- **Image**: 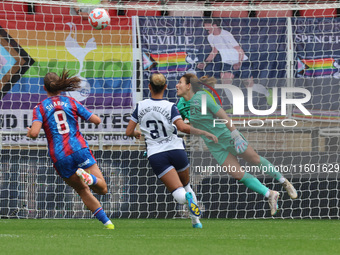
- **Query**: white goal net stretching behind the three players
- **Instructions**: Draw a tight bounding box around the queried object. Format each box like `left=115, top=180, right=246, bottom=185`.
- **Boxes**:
left=0, top=0, right=340, bottom=218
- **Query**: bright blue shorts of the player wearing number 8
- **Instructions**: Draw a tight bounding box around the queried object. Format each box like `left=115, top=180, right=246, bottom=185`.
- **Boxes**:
left=54, top=148, right=97, bottom=178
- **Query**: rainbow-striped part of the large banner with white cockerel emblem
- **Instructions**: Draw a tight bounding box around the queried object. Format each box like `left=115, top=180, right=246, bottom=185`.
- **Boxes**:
left=0, top=15, right=133, bottom=110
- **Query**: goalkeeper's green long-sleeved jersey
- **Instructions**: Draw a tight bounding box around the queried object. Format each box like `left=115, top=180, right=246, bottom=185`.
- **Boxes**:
left=177, top=91, right=230, bottom=145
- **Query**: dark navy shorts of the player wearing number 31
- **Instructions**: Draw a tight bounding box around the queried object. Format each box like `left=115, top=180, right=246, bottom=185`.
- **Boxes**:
left=149, top=150, right=190, bottom=178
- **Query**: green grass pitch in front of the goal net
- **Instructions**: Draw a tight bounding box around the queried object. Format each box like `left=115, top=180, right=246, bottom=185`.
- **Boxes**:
left=0, top=219, right=340, bottom=255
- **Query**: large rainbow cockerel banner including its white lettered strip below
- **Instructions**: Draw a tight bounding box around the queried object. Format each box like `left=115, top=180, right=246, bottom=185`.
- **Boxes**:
left=0, top=14, right=134, bottom=135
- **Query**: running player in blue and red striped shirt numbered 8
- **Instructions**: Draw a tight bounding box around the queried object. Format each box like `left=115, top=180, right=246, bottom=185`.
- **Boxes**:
left=27, top=70, right=114, bottom=229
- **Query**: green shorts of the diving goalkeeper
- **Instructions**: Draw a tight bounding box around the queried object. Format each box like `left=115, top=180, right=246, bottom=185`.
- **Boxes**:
left=204, top=132, right=246, bottom=165
